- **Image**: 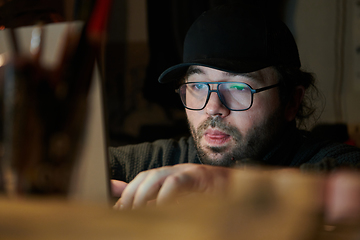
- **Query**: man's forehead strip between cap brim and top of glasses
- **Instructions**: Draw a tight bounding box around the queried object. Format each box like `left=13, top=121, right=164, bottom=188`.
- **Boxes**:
left=185, top=65, right=277, bottom=83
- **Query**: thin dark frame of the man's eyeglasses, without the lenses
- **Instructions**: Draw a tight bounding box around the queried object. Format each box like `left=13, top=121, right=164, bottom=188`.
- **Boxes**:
left=175, top=82, right=280, bottom=111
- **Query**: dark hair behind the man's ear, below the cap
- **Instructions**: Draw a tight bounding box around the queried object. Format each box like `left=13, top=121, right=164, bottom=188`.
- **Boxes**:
left=274, top=66, right=319, bottom=127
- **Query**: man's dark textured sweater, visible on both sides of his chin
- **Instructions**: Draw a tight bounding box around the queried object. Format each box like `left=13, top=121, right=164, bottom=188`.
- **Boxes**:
left=109, top=129, right=360, bottom=182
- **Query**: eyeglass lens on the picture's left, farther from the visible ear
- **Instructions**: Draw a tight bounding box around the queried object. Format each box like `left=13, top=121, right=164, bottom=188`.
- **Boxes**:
left=179, top=83, right=209, bottom=110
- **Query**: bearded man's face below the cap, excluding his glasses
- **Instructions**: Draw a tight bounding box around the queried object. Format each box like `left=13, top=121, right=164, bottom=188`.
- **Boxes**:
left=186, top=66, right=286, bottom=166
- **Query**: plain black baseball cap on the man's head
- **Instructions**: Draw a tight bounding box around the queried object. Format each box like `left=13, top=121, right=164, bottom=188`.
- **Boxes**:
left=159, top=4, right=301, bottom=83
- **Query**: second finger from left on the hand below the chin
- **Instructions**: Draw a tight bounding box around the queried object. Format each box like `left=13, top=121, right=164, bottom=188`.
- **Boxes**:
left=133, top=167, right=176, bottom=209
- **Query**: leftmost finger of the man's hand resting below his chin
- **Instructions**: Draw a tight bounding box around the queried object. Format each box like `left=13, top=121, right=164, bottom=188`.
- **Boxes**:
left=119, top=171, right=150, bottom=209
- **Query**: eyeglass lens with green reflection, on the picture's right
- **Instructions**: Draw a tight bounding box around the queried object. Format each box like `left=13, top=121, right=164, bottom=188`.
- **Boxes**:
left=218, top=82, right=252, bottom=110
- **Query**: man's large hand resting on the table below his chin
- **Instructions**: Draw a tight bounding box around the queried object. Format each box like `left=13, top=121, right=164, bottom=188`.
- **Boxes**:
left=114, top=163, right=234, bottom=209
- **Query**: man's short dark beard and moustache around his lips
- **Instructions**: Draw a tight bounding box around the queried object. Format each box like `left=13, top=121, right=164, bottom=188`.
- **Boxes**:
left=189, top=108, right=286, bottom=167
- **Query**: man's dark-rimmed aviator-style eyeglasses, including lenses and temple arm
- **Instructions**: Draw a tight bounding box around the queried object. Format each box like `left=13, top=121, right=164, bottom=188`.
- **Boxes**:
left=175, top=82, right=279, bottom=111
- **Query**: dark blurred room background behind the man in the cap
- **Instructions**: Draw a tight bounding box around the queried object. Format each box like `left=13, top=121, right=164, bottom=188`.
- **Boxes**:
left=0, top=0, right=360, bottom=146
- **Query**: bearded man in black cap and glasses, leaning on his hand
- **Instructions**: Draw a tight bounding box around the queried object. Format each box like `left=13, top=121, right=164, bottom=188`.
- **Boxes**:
left=110, top=4, right=360, bottom=209
